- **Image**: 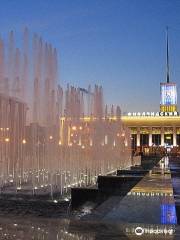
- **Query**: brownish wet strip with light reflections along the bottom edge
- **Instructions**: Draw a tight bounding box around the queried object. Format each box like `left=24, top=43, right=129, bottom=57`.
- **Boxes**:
left=0, top=217, right=177, bottom=240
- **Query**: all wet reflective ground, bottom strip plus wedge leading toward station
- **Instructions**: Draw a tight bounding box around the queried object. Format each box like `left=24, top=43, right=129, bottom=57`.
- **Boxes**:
left=0, top=158, right=180, bottom=240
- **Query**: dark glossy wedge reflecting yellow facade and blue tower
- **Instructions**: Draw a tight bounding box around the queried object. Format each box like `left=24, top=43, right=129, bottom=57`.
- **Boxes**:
left=83, top=158, right=177, bottom=224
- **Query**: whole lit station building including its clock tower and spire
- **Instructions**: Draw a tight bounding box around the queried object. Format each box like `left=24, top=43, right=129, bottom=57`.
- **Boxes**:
left=122, top=28, right=180, bottom=155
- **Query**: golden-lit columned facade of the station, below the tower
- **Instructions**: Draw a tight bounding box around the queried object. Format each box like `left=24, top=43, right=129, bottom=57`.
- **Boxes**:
left=122, top=112, right=180, bottom=155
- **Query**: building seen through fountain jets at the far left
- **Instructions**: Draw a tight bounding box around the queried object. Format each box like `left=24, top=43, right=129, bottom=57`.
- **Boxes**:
left=0, top=93, right=27, bottom=177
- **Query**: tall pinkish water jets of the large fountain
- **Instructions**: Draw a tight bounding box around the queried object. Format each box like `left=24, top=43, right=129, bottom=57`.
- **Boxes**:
left=0, top=28, right=131, bottom=201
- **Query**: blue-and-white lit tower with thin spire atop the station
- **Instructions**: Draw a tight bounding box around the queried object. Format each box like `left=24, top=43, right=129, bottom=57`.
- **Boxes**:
left=160, top=27, right=177, bottom=112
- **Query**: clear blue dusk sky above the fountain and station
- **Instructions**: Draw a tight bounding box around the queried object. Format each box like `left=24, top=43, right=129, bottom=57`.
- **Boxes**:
left=0, top=0, right=180, bottom=111
